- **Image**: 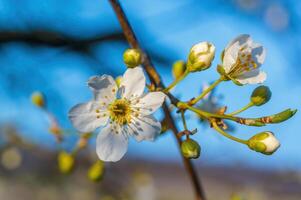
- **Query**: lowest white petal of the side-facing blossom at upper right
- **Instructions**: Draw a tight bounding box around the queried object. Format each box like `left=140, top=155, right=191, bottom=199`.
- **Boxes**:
left=236, top=70, right=267, bottom=84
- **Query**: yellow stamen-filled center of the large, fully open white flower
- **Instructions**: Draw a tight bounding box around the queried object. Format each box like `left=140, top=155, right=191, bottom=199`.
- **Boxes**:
left=109, top=99, right=132, bottom=125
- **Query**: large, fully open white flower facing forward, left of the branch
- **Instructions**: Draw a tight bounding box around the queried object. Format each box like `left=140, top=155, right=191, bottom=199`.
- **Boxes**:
left=69, top=67, right=165, bottom=162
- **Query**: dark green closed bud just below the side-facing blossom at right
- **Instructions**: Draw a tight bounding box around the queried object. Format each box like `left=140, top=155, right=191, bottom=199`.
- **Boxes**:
left=251, top=85, right=272, bottom=106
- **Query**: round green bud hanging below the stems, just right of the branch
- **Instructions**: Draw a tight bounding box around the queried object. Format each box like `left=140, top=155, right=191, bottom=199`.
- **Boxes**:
left=181, top=139, right=201, bottom=159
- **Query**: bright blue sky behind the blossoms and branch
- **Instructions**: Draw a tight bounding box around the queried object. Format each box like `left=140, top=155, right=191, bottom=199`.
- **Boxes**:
left=0, top=0, right=301, bottom=169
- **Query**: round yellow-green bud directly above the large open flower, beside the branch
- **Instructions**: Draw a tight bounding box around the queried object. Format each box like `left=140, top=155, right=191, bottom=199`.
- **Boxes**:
left=123, top=49, right=142, bottom=68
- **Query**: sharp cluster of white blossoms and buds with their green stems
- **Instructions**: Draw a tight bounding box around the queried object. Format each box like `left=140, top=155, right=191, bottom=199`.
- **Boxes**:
left=69, top=35, right=296, bottom=162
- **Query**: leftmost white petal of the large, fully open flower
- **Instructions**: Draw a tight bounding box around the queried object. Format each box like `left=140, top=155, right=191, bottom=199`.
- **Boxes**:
left=68, top=101, right=108, bottom=132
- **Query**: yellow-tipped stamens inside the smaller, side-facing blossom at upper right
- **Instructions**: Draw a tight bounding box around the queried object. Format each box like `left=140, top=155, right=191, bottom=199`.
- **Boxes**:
left=229, top=47, right=257, bottom=77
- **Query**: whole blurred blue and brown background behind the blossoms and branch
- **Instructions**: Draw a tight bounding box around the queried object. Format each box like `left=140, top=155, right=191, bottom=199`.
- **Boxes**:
left=0, top=0, right=301, bottom=200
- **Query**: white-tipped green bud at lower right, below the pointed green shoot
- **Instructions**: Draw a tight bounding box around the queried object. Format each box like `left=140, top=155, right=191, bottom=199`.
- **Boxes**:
left=248, top=131, right=280, bottom=155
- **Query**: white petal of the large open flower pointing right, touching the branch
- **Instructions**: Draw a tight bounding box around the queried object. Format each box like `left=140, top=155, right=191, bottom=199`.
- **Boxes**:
left=132, top=92, right=166, bottom=115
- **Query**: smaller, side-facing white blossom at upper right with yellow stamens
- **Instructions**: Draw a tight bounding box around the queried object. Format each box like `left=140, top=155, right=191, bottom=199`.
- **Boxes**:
left=222, top=34, right=266, bottom=84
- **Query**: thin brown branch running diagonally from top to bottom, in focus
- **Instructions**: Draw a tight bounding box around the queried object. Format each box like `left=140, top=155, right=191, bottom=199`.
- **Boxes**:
left=109, top=0, right=205, bottom=200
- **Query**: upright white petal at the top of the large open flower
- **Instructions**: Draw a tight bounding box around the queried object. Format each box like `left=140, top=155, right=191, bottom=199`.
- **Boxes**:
left=120, top=67, right=145, bottom=99
